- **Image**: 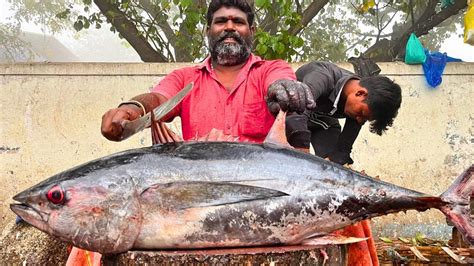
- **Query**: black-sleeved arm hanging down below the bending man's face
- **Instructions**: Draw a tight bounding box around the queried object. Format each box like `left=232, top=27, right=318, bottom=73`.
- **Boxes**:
left=328, top=118, right=362, bottom=165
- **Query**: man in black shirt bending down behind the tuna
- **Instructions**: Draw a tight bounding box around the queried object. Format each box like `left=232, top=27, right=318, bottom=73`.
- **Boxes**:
left=286, top=62, right=402, bottom=165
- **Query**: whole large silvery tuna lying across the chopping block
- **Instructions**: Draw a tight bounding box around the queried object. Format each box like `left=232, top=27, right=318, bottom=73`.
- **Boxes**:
left=11, top=115, right=474, bottom=253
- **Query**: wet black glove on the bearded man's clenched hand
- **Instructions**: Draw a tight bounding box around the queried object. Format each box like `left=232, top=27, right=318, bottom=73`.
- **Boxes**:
left=266, top=79, right=316, bottom=115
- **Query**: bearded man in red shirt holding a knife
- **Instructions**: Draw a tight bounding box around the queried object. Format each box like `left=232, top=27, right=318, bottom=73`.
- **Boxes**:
left=101, top=0, right=315, bottom=142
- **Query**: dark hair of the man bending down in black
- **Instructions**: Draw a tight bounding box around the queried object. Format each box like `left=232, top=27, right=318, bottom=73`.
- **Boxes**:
left=359, top=76, right=402, bottom=135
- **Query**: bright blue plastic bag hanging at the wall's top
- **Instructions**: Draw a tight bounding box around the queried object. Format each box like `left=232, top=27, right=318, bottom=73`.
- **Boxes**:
left=423, top=50, right=461, bottom=88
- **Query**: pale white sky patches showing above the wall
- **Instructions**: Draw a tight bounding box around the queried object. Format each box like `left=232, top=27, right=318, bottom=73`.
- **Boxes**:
left=0, top=0, right=474, bottom=62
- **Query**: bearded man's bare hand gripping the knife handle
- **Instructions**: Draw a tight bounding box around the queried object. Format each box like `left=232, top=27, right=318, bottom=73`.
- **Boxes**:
left=100, top=104, right=143, bottom=141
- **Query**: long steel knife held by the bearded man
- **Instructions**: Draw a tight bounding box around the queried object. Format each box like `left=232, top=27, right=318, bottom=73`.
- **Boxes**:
left=121, top=82, right=194, bottom=140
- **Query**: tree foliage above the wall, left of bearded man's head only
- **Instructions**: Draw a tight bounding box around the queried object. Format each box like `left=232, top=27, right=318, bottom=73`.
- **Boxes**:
left=56, top=0, right=207, bottom=61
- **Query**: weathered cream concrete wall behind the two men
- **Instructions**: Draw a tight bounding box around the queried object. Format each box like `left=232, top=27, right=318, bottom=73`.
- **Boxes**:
left=0, top=63, right=474, bottom=237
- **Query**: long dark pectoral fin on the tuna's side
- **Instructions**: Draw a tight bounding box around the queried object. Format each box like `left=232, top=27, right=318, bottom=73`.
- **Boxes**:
left=141, top=181, right=288, bottom=209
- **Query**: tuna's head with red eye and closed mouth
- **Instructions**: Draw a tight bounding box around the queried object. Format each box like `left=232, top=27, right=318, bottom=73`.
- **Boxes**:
left=10, top=170, right=142, bottom=254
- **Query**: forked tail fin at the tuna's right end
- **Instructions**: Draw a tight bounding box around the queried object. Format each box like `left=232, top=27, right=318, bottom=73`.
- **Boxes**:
left=440, top=165, right=474, bottom=245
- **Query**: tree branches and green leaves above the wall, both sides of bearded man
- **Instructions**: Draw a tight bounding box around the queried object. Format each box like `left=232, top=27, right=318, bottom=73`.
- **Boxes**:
left=1, top=0, right=466, bottom=62
